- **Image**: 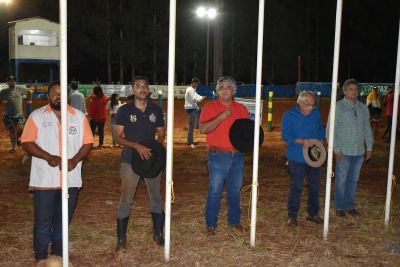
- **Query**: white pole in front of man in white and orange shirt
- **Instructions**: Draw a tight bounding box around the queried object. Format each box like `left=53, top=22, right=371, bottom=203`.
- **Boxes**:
left=60, top=0, right=69, bottom=266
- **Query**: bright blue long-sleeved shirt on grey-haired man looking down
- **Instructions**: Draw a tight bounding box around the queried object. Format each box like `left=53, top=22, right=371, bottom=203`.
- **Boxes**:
left=282, top=106, right=325, bottom=163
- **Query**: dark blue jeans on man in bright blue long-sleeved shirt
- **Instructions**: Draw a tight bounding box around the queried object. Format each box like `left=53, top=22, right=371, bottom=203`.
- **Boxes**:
left=288, top=160, right=322, bottom=219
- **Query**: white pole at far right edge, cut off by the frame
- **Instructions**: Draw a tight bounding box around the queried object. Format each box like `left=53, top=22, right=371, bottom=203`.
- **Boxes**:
left=385, top=19, right=400, bottom=229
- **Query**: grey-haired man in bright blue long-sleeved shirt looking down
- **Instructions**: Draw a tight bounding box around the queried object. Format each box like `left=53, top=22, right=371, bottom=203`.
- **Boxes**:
left=282, top=91, right=325, bottom=227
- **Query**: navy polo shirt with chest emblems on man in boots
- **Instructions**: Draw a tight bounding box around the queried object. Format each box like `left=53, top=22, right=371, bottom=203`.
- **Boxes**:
left=115, top=101, right=164, bottom=163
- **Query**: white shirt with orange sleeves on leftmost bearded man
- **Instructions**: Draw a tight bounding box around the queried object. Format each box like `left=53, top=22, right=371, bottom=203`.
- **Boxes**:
left=21, top=105, right=93, bottom=189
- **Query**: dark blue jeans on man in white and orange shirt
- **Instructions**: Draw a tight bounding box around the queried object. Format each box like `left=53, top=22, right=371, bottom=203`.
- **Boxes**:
left=33, top=187, right=78, bottom=261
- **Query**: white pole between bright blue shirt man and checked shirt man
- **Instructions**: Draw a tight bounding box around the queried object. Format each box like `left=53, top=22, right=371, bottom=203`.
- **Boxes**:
left=323, top=0, right=343, bottom=243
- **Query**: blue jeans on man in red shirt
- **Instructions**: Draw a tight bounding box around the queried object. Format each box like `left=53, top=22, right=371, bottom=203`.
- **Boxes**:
left=205, top=151, right=244, bottom=227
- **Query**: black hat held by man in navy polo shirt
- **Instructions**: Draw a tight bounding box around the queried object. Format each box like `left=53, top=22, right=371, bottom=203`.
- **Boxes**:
left=131, top=140, right=166, bottom=178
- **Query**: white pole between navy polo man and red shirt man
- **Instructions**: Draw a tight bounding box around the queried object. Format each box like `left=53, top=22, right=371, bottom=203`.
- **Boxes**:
left=164, top=0, right=176, bottom=261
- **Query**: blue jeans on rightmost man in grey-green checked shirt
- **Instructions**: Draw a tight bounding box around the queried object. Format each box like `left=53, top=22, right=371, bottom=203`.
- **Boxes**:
left=335, top=155, right=364, bottom=210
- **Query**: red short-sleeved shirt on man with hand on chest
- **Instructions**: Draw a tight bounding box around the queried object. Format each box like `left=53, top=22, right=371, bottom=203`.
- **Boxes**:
left=200, top=99, right=249, bottom=149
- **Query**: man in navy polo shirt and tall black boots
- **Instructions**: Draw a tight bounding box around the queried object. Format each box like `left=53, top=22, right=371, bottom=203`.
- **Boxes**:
left=114, top=76, right=165, bottom=251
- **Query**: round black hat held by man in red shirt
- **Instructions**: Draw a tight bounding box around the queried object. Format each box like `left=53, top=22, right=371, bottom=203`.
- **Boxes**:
left=229, top=119, right=264, bottom=152
